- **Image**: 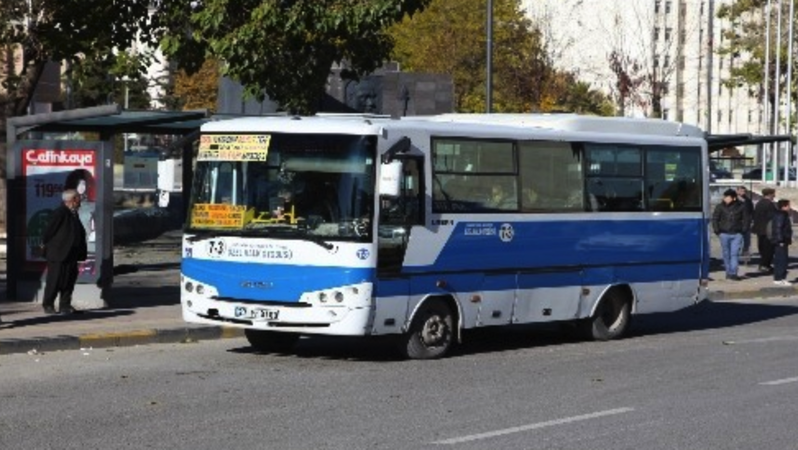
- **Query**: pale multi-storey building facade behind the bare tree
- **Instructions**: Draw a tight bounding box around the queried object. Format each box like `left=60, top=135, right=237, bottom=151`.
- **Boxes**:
left=522, top=0, right=765, bottom=134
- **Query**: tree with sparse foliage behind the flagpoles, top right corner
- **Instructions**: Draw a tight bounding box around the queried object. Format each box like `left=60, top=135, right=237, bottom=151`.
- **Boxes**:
left=717, top=0, right=798, bottom=124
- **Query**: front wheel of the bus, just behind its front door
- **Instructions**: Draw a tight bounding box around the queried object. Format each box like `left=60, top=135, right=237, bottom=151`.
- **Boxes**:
left=399, top=300, right=454, bottom=359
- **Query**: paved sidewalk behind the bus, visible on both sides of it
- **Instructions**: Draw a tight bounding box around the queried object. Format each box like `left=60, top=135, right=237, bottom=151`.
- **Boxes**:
left=0, top=181, right=798, bottom=354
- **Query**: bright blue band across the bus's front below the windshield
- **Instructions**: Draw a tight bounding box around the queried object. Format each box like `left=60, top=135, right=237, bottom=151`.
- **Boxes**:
left=181, top=258, right=374, bottom=303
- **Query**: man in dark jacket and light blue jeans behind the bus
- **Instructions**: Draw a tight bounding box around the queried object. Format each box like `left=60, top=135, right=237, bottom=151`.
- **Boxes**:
left=712, top=189, right=751, bottom=280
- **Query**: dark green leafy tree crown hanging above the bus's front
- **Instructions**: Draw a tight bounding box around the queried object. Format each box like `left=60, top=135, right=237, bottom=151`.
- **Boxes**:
left=152, top=0, right=429, bottom=113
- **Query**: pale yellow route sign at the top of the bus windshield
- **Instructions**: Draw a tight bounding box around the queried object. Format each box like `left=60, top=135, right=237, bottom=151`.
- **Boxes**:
left=197, top=134, right=271, bottom=161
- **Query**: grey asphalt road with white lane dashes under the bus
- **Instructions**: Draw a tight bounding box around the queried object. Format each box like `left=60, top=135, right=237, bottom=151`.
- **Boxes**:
left=0, top=298, right=798, bottom=450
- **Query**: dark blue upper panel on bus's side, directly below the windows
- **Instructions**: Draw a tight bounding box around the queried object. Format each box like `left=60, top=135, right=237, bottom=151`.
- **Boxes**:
left=404, top=218, right=708, bottom=276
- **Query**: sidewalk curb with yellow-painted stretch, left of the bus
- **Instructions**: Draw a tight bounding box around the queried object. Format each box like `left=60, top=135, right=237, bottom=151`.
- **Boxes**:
left=0, top=326, right=244, bottom=355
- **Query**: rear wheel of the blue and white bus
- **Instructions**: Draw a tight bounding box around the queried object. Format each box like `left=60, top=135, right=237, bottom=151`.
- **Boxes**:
left=579, top=289, right=632, bottom=341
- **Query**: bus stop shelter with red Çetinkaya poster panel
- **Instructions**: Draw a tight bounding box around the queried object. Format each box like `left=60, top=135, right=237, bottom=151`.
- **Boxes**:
left=6, top=105, right=209, bottom=309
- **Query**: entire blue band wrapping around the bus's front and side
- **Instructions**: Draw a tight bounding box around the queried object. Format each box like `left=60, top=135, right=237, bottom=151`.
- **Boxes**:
left=183, top=218, right=709, bottom=302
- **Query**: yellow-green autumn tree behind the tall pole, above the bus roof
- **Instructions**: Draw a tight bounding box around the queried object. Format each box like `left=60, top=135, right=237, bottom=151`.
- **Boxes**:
left=391, top=0, right=612, bottom=114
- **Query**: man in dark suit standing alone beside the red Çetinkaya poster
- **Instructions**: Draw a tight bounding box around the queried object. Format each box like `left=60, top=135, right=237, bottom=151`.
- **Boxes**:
left=42, top=189, right=87, bottom=314
